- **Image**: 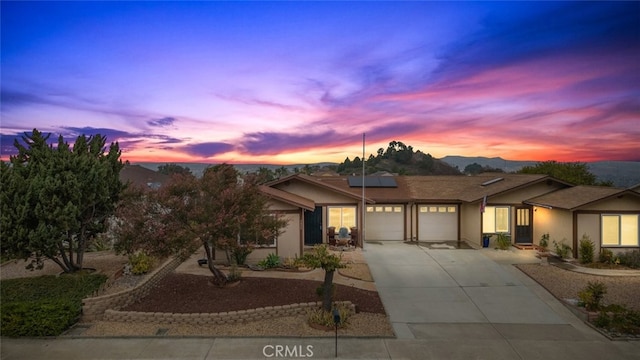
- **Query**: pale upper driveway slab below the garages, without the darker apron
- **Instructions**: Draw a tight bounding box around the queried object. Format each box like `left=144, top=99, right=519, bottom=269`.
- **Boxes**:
left=365, top=242, right=567, bottom=338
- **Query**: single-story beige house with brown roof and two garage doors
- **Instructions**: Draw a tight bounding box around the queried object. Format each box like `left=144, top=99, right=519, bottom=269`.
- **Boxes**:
left=256, top=173, right=640, bottom=261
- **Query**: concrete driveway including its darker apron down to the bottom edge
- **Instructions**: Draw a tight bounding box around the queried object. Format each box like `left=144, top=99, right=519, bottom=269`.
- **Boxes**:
left=364, top=241, right=640, bottom=359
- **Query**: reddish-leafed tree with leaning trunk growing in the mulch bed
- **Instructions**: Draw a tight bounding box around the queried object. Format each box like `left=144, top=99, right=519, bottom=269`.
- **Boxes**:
left=114, top=164, right=287, bottom=286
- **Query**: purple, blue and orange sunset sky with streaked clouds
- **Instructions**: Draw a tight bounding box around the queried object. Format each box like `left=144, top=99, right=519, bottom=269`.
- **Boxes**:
left=0, top=1, right=640, bottom=164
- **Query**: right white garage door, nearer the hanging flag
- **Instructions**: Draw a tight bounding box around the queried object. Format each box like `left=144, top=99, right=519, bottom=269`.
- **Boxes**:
left=418, top=205, right=458, bottom=241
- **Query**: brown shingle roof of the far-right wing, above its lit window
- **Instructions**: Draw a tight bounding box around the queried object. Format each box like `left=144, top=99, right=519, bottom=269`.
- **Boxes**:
left=525, top=185, right=639, bottom=210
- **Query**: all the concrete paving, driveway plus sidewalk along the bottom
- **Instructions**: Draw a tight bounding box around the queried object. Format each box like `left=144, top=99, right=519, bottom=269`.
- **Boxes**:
left=0, top=242, right=640, bottom=360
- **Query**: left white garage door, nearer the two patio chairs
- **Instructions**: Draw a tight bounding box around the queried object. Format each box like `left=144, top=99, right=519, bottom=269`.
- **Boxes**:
left=365, top=205, right=404, bottom=241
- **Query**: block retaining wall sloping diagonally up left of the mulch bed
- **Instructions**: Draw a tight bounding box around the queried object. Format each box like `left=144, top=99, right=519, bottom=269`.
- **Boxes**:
left=81, top=257, right=184, bottom=322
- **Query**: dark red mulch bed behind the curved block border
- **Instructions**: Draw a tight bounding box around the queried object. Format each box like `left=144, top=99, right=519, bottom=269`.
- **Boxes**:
left=122, top=273, right=385, bottom=314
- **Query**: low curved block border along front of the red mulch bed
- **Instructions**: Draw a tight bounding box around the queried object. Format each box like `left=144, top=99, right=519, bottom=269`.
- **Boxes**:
left=102, top=301, right=356, bottom=325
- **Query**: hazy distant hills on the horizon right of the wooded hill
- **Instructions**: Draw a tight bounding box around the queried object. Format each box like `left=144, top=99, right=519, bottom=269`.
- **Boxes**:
left=441, top=156, right=640, bottom=188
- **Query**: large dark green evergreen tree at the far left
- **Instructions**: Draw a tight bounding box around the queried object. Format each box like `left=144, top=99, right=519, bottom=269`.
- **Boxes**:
left=0, top=129, right=124, bottom=272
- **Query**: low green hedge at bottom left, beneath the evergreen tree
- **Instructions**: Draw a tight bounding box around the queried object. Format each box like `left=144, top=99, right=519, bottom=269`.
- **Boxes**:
left=0, top=274, right=107, bottom=336
